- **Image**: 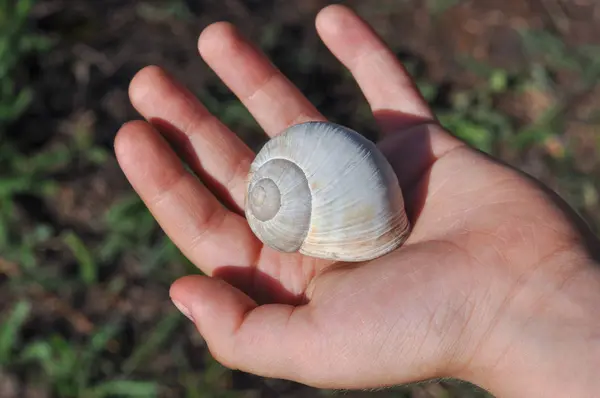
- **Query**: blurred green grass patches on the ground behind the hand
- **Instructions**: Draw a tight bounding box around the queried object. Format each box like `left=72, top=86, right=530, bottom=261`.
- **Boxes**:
left=0, top=0, right=600, bottom=398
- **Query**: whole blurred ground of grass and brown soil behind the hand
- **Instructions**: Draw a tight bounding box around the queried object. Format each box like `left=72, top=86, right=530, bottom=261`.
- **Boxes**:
left=0, top=0, right=600, bottom=398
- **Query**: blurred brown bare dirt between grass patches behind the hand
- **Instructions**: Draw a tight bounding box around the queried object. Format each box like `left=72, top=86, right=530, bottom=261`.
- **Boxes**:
left=7, top=0, right=600, bottom=397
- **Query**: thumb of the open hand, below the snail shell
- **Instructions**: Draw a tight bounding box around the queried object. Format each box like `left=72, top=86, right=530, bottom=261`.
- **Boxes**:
left=170, top=275, right=319, bottom=385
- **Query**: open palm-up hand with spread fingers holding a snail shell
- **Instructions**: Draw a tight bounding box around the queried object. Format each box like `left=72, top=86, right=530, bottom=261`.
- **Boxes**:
left=115, top=5, right=600, bottom=397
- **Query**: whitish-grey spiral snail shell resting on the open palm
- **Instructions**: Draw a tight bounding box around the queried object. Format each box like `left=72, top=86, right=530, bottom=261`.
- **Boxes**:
left=245, top=122, right=410, bottom=261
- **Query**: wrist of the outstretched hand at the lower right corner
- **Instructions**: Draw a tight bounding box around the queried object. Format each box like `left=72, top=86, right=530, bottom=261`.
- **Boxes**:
left=459, top=252, right=600, bottom=398
